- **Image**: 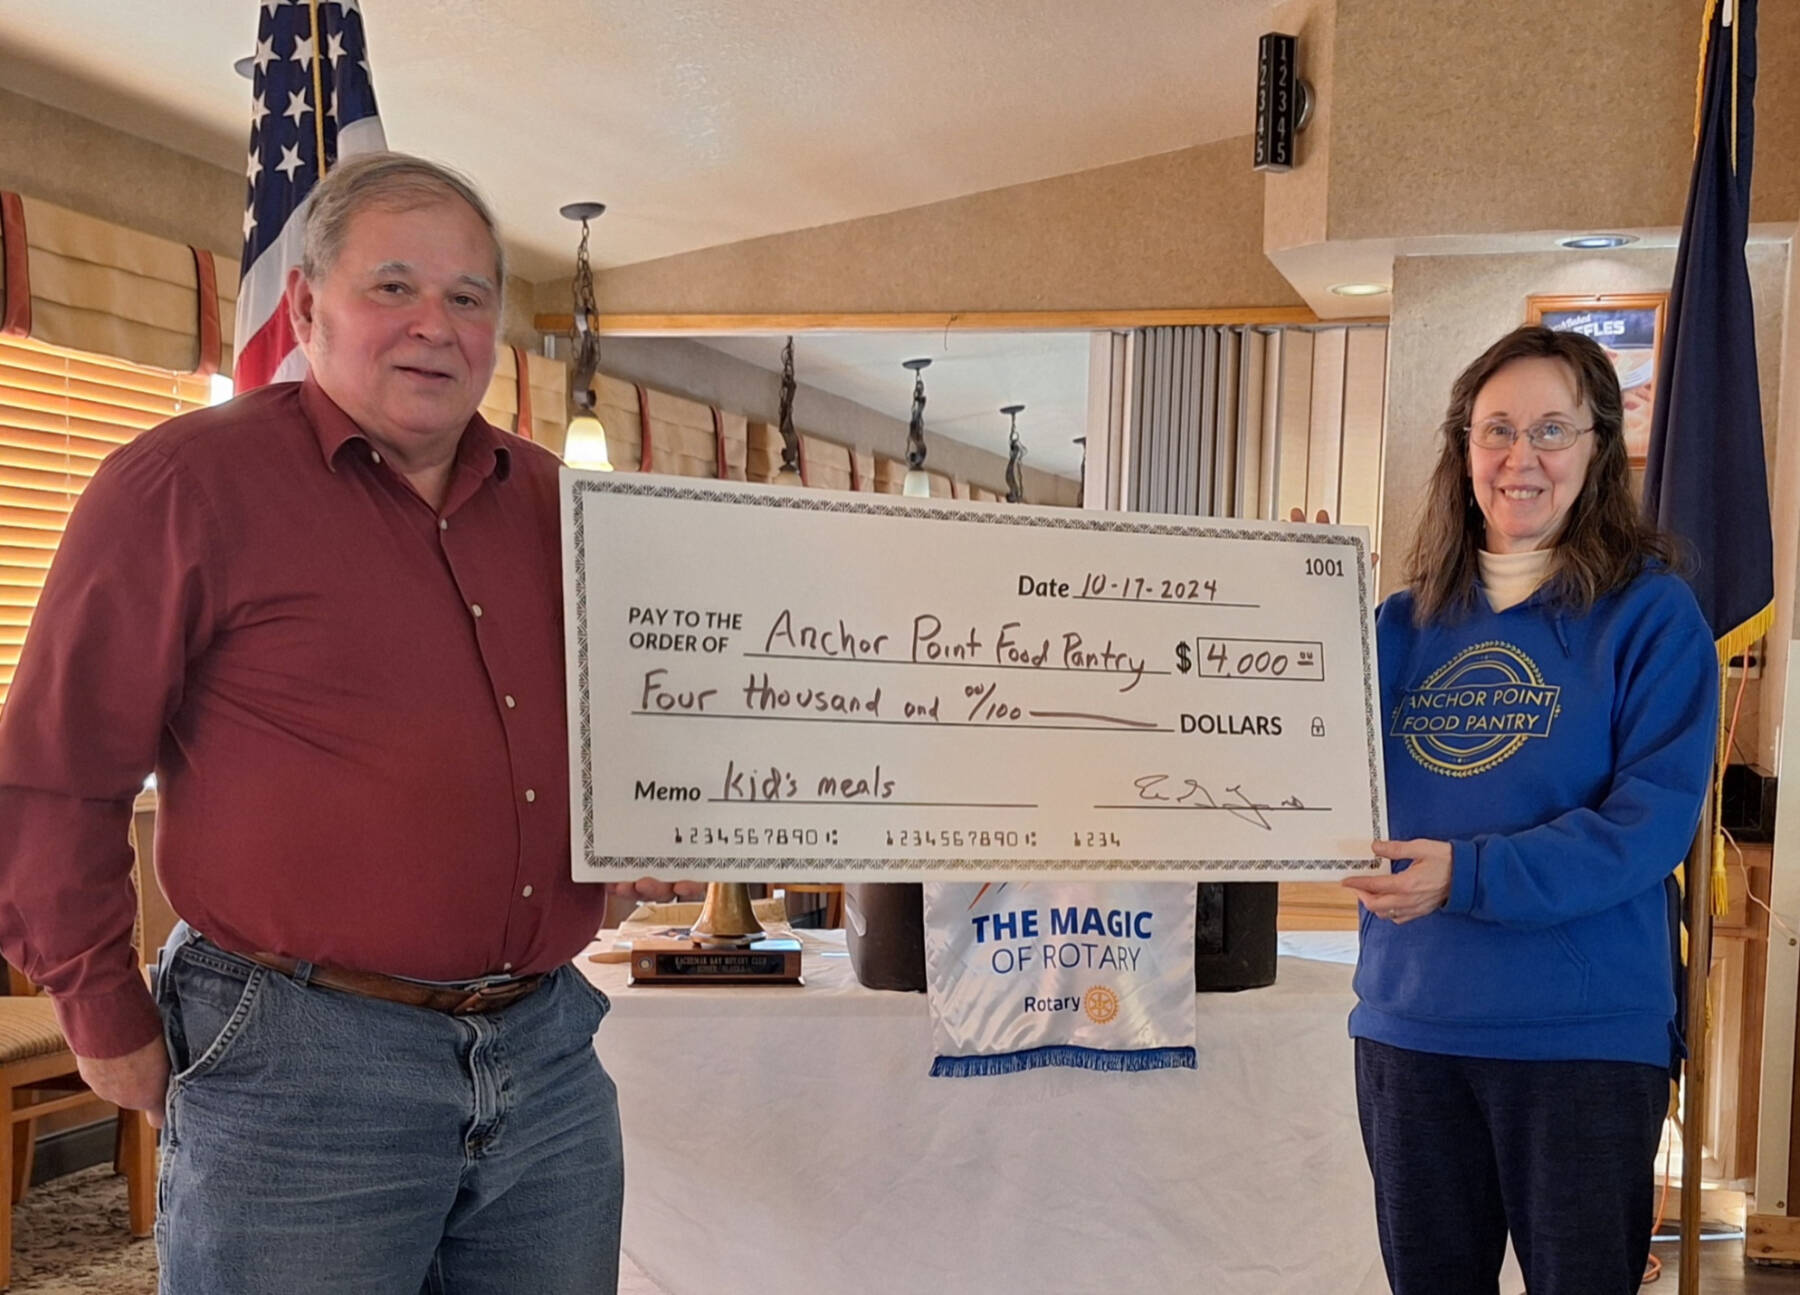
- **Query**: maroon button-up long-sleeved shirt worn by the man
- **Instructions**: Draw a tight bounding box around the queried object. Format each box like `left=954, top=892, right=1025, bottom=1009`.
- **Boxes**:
left=0, top=380, right=605, bottom=1057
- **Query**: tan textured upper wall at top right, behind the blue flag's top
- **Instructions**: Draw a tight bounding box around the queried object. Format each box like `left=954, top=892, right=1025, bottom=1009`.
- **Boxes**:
left=1328, top=0, right=1800, bottom=240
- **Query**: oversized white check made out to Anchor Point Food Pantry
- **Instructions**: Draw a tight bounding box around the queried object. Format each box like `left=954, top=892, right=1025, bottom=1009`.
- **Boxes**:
left=563, top=472, right=1384, bottom=881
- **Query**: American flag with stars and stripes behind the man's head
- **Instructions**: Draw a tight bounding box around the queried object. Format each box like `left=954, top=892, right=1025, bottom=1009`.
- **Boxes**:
left=232, top=0, right=387, bottom=391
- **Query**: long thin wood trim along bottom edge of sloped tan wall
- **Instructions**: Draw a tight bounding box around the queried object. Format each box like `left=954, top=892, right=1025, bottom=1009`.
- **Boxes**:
left=531, top=306, right=1324, bottom=337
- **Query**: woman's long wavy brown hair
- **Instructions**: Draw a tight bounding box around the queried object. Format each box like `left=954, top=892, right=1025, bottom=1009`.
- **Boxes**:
left=1408, top=324, right=1679, bottom=625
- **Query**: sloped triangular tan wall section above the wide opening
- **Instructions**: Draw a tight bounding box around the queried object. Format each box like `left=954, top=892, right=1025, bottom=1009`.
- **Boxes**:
left=572, top=137, right=1301, bottom=313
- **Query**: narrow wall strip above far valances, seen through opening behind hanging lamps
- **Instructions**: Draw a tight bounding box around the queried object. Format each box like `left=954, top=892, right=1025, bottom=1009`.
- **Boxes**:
left=599, top=337, right=1080, bottom=506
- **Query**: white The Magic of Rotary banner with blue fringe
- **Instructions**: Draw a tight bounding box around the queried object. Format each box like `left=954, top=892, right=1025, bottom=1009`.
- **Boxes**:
left=925, top=883, right=1195, bottom=1075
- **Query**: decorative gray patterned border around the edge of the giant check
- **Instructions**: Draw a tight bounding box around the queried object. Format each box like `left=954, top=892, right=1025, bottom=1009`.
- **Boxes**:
left=565, top=474, right=1388, bottom=879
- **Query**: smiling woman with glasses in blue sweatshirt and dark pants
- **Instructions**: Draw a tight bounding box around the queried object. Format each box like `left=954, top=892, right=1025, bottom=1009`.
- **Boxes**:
left=1345, top=328, right=1717, bottom=1295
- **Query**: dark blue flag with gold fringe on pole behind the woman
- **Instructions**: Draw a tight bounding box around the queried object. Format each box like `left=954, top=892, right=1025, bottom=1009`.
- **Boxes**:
left=1643, top=0, right=1775, bottom=665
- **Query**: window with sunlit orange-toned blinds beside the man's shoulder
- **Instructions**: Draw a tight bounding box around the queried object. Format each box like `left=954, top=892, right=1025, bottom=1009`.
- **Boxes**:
left=0, top=337, right=230, bottom=706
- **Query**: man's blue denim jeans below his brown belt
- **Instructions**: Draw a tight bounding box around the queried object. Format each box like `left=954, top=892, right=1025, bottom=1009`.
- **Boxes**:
left=157, top=926, right=623, bottom=1295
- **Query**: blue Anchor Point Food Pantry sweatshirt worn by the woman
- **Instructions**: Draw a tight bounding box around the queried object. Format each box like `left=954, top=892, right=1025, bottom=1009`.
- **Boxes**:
left=1350, top=569, right=1719, bottom=1066
